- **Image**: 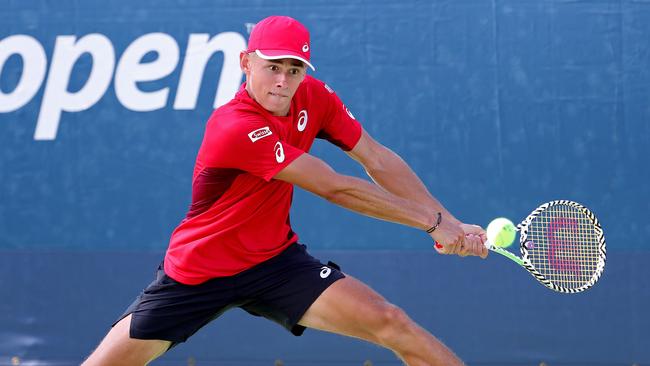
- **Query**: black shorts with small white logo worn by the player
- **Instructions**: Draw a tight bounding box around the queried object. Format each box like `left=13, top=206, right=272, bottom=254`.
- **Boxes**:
left=113, top=244, right=345, bottom=346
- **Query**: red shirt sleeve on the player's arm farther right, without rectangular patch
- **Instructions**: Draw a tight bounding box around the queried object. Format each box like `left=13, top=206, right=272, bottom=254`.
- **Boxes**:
left=316, top=84, right=362, bottom=151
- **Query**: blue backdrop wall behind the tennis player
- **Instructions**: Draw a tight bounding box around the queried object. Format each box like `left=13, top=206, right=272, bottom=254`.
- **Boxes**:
left=0, top=0, right=650, bottom=364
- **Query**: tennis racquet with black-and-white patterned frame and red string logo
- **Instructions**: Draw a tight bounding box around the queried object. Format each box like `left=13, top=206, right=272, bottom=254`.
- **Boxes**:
left=436, top=200, right=606, bottom=293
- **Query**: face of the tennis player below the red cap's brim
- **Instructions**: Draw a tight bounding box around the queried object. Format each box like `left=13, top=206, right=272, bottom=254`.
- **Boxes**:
left=239, top=52, right=307, bottom=116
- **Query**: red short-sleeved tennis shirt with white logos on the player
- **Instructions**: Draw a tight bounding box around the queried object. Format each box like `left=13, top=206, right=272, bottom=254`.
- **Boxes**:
left=165, top=76, right=361, bottom=285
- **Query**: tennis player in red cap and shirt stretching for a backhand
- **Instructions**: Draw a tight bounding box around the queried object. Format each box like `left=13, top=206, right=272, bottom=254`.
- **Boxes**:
left=84, top=16, right=487, bottom=365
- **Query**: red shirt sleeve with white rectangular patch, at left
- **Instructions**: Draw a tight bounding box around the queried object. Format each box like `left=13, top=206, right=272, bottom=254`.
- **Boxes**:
left=201, top=118, right=304, bottom=181
